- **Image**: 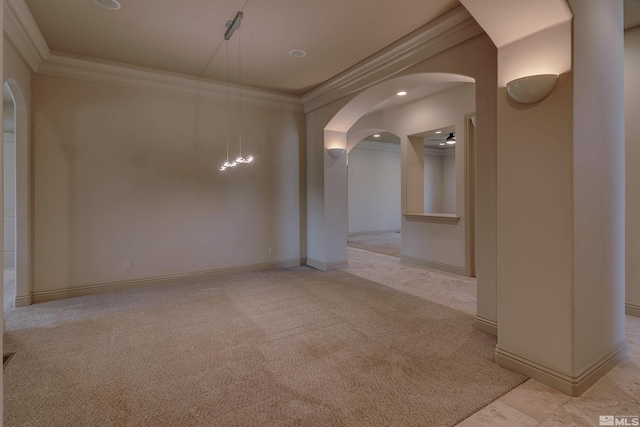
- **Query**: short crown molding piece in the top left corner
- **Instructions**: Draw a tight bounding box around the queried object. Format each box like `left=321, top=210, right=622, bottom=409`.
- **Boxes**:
left=3, top=0, right=49, bottom=72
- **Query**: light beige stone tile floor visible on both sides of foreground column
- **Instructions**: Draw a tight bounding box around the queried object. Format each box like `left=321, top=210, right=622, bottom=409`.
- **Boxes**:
left=346, top=242, right=640, bottom=427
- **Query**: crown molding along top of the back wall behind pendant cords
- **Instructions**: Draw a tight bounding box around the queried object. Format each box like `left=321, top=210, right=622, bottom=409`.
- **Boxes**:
left=38, top=52, right=303, bottom=113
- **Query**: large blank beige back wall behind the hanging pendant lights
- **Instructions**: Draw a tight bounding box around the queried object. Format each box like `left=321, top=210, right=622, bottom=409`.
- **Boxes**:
left=33, top=75, right=305, bottom=300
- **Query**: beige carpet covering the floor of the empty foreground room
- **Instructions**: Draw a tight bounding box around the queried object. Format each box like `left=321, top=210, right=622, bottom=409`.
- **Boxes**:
left=4, top=267, right=525, bottom=427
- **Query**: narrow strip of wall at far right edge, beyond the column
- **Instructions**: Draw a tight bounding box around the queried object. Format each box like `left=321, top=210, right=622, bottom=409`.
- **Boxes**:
left=624, top=27, right=640, bottom=316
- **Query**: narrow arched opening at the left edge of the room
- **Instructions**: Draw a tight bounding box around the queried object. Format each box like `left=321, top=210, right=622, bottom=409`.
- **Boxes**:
left=3, top=78, right=31, bottom=308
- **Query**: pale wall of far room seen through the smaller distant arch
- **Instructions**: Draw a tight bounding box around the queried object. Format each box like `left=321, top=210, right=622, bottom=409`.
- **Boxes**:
left=347, top=141, right=400, bottom=233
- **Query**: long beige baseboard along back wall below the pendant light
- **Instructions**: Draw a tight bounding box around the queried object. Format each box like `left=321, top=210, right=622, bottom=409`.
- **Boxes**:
left=33, top=258, right=304, bottom=303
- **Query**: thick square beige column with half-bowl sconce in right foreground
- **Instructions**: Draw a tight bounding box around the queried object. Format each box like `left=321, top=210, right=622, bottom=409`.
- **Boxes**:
left=496, top=0, right=626, bottom=395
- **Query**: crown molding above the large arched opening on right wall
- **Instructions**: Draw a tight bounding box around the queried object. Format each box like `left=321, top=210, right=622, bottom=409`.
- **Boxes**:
left=302, top=6, right=483, bottom=113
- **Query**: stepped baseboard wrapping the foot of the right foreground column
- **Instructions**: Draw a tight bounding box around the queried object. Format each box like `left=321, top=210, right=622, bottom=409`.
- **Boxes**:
left=496, top=340, right=627, bottom=396
